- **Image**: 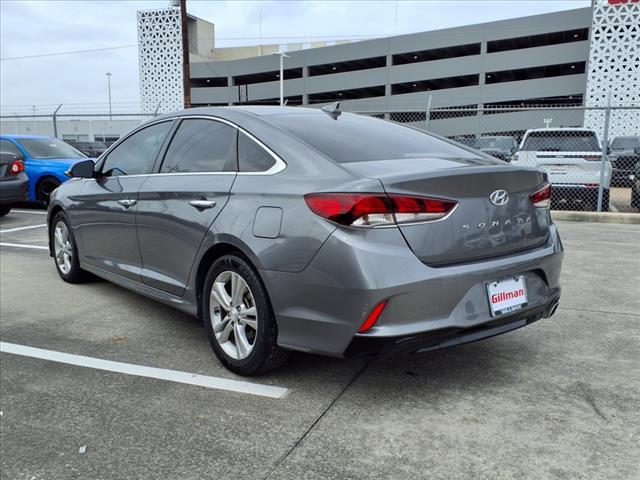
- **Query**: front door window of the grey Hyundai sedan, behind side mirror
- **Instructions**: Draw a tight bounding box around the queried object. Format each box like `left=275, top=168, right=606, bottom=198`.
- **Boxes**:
left=102, top=121, right=173, bottom=177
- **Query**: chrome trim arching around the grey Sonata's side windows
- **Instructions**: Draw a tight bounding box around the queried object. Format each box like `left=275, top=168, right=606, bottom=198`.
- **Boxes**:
left=96, top=115, right=287, bottom=177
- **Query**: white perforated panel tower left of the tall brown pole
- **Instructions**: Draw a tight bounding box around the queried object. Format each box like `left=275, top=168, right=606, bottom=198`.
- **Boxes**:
left=138, top=8, right=184, bottom=112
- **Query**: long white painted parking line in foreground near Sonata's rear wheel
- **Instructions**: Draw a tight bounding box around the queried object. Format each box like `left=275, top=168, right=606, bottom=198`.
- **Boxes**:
left=0, top=342, right=289, bottom=398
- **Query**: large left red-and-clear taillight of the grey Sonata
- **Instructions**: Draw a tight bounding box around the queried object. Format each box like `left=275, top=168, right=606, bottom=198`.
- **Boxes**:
left=304, top=193, right=457, bottom=227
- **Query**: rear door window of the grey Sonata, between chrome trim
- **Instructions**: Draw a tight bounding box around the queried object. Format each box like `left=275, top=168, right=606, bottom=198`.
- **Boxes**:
left=160, top=119, right=238, bottom=173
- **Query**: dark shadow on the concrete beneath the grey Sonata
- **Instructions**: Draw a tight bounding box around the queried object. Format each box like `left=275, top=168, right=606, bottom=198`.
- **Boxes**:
left=82, top=282, right=538, bottom=401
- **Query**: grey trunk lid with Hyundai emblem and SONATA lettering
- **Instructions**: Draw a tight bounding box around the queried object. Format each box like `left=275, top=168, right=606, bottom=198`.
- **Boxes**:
left=343, top=159, right=551, bottom=266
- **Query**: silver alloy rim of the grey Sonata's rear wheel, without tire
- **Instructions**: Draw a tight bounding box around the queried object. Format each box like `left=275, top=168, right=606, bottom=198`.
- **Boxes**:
left=209, top=271, right=258, bottom=360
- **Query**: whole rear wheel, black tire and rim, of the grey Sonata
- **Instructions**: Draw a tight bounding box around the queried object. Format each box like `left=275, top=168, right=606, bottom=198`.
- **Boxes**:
left=201, top=254, right=289, bottom=375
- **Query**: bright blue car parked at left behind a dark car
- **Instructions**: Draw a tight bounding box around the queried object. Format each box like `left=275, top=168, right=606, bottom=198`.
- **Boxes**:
left=0, top=134, right=87, bottom=204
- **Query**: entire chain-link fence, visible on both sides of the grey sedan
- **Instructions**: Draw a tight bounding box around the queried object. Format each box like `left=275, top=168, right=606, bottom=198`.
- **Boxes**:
left=0, top=102, right=640, bottom=213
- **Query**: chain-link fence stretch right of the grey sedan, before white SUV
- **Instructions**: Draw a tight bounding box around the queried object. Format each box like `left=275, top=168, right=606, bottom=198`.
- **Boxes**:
left=350, top=106, right=640, bottom=212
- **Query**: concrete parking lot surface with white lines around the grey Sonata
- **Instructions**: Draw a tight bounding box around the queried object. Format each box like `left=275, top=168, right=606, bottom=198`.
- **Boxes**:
left=0, top=210, right=640, bottom=479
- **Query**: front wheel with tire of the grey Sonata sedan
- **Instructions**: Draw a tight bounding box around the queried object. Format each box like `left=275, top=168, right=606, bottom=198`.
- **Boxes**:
left=49, top=212, right=90, bottom=283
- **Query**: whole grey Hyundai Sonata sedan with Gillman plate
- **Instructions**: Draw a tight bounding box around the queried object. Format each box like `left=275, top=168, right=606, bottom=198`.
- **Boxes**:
left=48, top=107, right=563, bottom=375
